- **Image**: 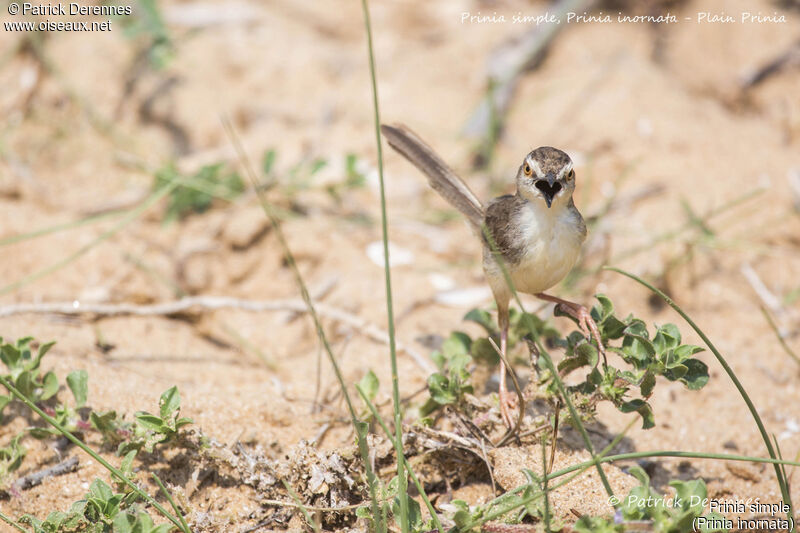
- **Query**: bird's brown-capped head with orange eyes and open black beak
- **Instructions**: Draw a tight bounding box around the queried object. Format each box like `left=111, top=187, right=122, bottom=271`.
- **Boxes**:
left=517, top=146, right=575, bottom=208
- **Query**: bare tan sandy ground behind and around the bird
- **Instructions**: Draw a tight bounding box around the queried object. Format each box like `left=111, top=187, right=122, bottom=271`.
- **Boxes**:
left=0, top=0, right=800, bottom=531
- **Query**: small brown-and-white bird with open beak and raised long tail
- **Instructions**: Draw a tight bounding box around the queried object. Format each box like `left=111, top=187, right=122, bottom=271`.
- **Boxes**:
left=381, top=124, right=605, bottom=428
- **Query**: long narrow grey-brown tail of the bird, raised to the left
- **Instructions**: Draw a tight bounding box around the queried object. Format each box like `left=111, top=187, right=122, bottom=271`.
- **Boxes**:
left=381, top=124, right=483, bottom=231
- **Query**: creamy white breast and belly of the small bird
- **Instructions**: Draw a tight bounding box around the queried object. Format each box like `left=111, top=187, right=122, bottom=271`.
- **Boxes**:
left=510, top=203, right=586, bottom=294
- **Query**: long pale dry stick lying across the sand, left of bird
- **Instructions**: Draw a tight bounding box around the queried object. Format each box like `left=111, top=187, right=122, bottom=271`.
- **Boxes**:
left=0, top=296, right=434, bottom=373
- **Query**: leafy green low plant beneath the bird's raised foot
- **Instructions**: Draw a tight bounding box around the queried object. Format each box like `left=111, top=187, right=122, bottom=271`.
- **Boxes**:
left=420, top=294, right=708, bottom=429
